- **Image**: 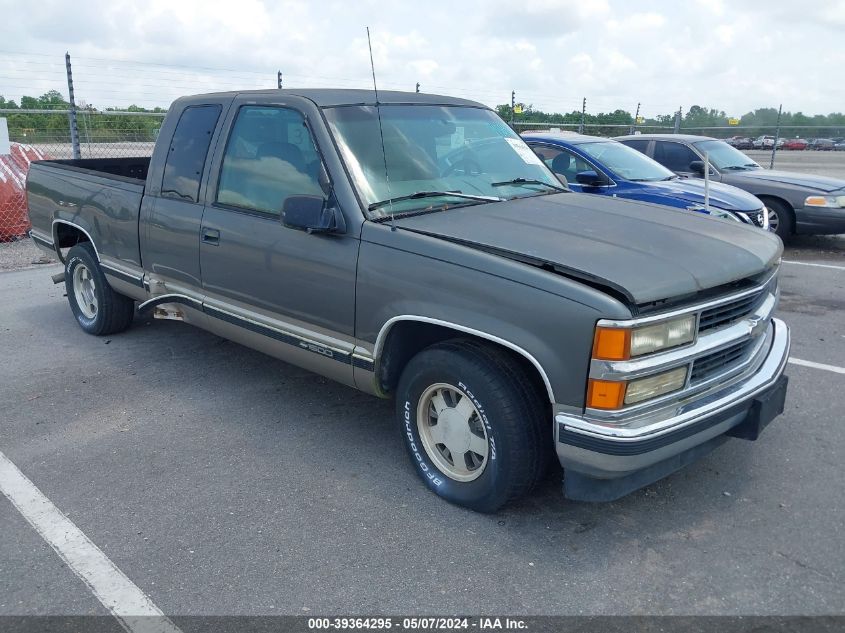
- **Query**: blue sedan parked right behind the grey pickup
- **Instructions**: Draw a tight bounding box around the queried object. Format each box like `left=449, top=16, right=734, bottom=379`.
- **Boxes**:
left=522, top=132, right=769, bottom=230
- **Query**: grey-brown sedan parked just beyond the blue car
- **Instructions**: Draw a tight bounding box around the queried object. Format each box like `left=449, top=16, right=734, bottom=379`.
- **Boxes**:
left=617, top=134, right=845, bottom=239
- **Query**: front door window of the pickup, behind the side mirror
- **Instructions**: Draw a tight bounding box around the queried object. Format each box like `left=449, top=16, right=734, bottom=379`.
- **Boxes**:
left=217, top=106, right=324, bottom=216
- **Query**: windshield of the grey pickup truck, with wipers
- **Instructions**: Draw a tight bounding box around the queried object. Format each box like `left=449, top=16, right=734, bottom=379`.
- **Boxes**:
left=324, top=105, right=560, bottom=218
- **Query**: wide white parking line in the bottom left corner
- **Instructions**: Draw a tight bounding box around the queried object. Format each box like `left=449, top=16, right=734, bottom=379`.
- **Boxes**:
left=0, top=452, right=181, bottom=633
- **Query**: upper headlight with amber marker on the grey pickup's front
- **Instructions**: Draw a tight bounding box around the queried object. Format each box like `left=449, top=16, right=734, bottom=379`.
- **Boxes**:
left=593, top=314, right=695, bottom=360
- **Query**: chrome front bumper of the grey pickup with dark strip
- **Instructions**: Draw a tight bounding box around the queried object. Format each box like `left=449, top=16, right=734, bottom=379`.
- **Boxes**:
left=555, top=319, right=790, bottom=494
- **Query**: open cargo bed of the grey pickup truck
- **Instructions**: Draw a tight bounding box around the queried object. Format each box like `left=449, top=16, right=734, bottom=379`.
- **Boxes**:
left=27, top=157, right=150, bottom=269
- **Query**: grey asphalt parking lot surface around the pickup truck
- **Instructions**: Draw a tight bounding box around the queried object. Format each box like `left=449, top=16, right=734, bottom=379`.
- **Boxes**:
left=0, top=232, right=845, bottom=615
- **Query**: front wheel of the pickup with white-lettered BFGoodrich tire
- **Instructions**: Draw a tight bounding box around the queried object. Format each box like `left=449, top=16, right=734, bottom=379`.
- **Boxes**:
left=396, top=341, right=552, bottom=512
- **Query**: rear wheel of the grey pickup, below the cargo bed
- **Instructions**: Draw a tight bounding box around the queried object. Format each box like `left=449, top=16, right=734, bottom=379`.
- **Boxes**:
left=65, top=242, right=135, bottom=336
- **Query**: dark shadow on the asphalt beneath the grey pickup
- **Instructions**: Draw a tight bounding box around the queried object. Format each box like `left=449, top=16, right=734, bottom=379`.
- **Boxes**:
left=11, top=301, right=764, bottom=570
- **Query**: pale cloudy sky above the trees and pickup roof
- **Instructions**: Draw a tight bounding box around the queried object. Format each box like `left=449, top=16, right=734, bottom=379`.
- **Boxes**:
left=0, top=0, right=845, bottom=116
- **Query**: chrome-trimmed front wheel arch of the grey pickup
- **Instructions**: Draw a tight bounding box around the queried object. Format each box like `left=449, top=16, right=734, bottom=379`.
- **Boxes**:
left=373, top=315, right=555, bottom=404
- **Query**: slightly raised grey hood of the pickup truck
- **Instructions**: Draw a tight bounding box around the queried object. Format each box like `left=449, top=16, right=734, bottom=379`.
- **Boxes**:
left=394, top=193, right=783, bottom=304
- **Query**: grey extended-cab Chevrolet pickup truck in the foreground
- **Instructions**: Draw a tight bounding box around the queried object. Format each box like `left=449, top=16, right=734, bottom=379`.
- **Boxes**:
left=27, top=90, right=789, bottom=512
